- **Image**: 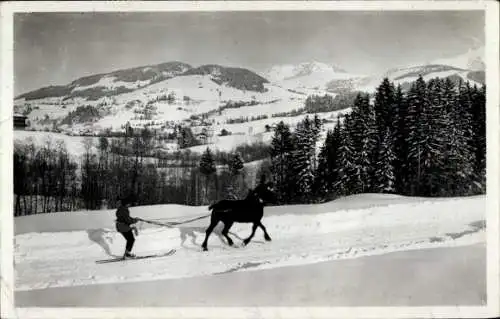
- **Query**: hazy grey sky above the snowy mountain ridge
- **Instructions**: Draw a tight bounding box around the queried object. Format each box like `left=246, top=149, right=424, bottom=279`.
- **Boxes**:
left=14, top=11, right=484, bottom=95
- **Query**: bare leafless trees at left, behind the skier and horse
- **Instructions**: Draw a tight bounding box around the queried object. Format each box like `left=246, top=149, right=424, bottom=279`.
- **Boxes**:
left=14, top=134, right=268, bottom=216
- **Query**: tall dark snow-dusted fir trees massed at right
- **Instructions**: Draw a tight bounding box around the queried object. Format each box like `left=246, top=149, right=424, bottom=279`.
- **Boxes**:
left=270, top=77, right=486, bottom=203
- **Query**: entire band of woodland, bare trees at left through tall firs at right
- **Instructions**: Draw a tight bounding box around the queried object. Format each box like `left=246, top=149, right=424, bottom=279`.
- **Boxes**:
left=13, top=77, right=486, bottom=216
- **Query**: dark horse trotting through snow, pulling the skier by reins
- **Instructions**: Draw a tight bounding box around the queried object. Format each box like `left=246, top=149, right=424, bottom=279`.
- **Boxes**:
left=201, top=183, right=276, bottom=251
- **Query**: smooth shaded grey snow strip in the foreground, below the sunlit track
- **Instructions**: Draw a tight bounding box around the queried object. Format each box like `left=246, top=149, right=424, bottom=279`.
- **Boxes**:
left=15, top=244, right=486, bottom=308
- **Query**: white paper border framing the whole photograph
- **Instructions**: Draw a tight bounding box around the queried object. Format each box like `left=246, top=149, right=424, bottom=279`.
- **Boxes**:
left=0, top=1, right=500, bottom=319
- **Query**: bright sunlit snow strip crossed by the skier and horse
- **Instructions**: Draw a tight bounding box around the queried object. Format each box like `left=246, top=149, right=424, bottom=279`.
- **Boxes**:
left=15, top=196, right=485, bottom=291
